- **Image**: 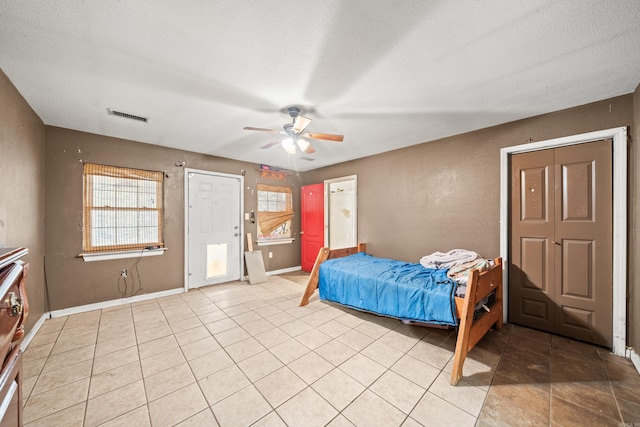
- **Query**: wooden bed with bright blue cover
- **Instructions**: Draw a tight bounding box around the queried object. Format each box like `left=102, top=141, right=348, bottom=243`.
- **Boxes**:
left=300, top=243, right=503, bottom=385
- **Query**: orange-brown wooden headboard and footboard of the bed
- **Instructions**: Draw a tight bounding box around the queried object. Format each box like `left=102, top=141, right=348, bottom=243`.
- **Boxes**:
left=300, top=243, right=502, bottom=385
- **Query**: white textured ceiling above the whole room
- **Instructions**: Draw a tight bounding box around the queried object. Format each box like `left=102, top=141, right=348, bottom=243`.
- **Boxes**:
left=0, top=0, right=640, bottom=170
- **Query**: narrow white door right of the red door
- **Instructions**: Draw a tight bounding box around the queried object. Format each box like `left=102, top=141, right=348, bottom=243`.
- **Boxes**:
left=325, top=175, right=358, bottom=249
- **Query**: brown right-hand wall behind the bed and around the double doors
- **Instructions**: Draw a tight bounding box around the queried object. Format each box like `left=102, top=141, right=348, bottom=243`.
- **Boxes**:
left=304, top=96, right=640, bottom=344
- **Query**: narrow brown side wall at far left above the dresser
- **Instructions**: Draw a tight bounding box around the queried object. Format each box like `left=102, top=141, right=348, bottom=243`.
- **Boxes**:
left=0, top=70, right=45, bottom=332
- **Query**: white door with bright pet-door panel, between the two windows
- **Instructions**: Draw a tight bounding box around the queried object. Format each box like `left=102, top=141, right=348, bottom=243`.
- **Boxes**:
left=185, top=171, right=243, bottom=288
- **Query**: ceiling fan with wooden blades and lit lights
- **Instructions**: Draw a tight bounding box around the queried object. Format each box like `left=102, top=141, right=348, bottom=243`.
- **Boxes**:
left=244, top=107, right=344, bottom=154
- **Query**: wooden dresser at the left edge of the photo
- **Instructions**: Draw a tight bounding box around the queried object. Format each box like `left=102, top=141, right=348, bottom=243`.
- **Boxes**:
left=0, top=248, right=29, bottom=427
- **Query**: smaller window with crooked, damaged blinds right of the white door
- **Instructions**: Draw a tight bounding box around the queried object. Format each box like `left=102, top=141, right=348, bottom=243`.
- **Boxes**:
left=258, top=184, right=293, bottom=242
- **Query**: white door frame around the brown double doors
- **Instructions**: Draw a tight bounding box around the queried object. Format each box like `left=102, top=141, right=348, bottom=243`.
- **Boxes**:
left=500, top=127, right=628, bottom=357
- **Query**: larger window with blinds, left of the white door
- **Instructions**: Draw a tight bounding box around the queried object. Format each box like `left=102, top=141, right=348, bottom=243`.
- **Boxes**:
left=83, top=163, right=164, bottom=252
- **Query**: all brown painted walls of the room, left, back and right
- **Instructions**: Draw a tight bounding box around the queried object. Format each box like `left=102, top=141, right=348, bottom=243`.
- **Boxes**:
left=0, top=62, right=640, bottom=353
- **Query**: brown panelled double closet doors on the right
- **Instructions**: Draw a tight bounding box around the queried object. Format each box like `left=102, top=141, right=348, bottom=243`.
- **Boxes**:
left=509, top=140, right=613, bottom=347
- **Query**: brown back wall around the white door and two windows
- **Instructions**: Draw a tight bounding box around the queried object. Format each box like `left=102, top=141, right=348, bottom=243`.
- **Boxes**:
left=45, top=126, right=300, bottom=310
